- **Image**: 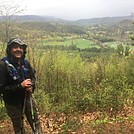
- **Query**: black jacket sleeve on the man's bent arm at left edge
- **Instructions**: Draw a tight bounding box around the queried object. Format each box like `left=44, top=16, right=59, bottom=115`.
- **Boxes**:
left=0, top=61, right=22, bottom=94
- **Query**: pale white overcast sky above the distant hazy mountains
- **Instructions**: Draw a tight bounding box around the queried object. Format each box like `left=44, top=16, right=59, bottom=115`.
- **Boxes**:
left=0, top=0, right=134, bottom=20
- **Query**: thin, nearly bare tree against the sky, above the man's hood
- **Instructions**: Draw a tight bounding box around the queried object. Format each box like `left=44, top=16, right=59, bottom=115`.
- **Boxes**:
left=0, top=1, right=23, bottom=44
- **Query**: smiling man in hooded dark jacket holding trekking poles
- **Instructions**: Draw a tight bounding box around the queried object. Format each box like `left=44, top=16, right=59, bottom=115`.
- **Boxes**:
left=0, top=38, right=42, bottom=134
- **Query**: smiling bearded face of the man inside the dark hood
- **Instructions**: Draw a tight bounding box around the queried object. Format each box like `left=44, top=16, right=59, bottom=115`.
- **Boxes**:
left=11, top=43, right=24, bottom=60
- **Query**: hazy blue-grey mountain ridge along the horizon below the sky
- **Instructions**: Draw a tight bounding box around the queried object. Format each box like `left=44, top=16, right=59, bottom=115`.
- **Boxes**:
left=0, top=15, right=134, bottom=25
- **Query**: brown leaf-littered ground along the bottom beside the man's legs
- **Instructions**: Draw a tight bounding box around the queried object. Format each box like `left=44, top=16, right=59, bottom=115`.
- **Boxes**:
left=0, top=110, right=134, bottom=134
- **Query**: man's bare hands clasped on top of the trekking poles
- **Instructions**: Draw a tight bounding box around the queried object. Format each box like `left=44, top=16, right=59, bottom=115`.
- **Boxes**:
left=21, top=79, right=33, bottom=92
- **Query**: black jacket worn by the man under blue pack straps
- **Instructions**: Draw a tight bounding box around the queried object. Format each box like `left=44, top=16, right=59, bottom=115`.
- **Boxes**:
left=0, top=60, right=35, bottom=105
